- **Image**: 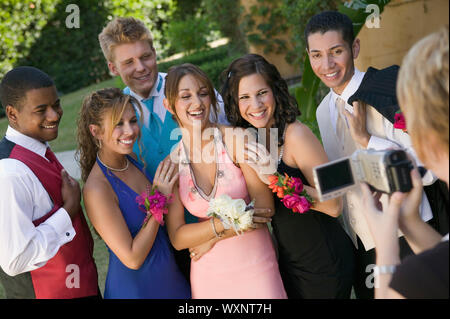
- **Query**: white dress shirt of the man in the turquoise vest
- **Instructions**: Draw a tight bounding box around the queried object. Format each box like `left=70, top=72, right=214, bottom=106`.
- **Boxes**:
left=130, top=72, right=229, bottom=127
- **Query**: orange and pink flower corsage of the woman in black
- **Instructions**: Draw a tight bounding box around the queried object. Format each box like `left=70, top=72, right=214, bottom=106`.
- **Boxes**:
left=269, top=173, right=313, bottom=214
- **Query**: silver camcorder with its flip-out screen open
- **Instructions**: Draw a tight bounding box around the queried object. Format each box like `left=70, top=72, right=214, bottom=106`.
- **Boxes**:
left=313, top=149, right=414, bottom=202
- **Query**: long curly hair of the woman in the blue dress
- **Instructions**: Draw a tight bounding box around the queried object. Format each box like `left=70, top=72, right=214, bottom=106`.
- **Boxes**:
left=76, top=88, right=142, bottom=182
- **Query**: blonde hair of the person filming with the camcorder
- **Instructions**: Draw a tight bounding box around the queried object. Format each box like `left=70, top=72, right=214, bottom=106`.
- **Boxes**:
left=397, top=25, right=449, bottom=161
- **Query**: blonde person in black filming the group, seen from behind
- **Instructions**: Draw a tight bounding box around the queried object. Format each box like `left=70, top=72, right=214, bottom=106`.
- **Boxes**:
left=356, top=26, right=449, bottom=299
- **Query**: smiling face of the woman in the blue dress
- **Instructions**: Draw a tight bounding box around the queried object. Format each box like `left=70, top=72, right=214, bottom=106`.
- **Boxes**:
left=96, top=103, right=139, bottom=154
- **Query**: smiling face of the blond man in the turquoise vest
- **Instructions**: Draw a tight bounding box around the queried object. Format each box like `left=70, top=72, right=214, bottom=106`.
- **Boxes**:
left=108, top=40, right=158, bottom=98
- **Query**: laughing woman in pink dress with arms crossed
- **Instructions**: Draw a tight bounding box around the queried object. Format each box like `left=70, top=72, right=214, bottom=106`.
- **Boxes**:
left=164, top=64, right=286, bottom=299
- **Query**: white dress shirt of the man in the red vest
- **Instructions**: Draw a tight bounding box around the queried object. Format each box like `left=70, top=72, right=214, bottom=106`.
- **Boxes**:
left=0, top=126, right=75, bottom=276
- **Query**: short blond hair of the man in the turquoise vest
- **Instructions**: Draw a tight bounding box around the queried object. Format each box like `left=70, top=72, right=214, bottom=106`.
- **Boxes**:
left=98, top=18, right=153, bottom=62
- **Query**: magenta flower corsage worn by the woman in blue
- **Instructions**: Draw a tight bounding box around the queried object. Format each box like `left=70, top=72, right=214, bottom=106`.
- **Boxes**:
left=136, top=185, right=173, bottom=228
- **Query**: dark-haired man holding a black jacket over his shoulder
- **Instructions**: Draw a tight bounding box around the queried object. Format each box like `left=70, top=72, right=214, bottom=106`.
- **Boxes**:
left=305, top=11, right=435, bottom=299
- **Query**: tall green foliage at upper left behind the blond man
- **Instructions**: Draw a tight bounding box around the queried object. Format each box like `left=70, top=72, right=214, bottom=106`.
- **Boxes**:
left=0, top=0, right=174, bottom=93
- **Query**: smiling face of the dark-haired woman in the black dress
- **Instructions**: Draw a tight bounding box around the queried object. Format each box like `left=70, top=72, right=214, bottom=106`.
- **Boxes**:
left=238, top=73, right=276, bottom=128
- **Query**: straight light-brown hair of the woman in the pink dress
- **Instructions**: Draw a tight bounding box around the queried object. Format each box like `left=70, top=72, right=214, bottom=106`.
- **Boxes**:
left=164, top=63, right=217, bottom=125
